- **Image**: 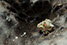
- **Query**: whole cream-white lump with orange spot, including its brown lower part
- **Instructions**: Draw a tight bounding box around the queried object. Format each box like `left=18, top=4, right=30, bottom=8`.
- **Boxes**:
left=37, top=19, right=54, bottom=34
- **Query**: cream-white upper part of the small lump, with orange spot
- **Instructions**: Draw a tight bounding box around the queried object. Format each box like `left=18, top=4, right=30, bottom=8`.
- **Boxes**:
left=37, top=19, right=54, bottom=30
